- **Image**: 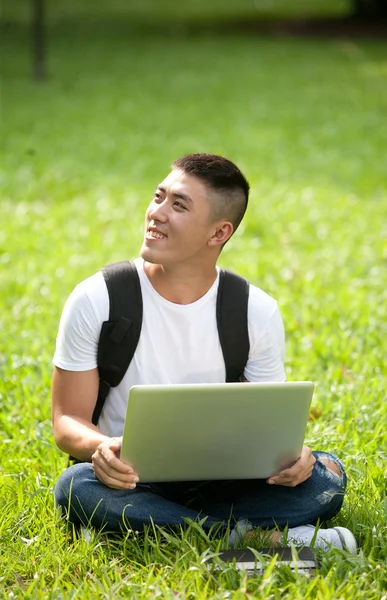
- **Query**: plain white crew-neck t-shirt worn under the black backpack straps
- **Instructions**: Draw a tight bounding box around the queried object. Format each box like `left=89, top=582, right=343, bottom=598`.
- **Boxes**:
left=53, top=258, right=285, bottom=436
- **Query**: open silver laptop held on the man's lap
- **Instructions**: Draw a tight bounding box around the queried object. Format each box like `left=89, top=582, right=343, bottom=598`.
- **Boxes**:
left=121, top=381, right=313, bottom=482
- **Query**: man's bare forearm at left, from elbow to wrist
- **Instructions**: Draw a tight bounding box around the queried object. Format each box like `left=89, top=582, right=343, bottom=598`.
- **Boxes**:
left=54, top=415, right=109, bottom=461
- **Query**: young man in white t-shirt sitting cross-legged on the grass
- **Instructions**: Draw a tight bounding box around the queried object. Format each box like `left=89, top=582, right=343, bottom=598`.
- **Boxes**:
left=52, top=154, right=356, bottom=550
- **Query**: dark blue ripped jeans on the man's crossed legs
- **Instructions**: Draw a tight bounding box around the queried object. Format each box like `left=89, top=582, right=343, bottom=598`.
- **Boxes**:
left=55, top=452, right=347, bottom=532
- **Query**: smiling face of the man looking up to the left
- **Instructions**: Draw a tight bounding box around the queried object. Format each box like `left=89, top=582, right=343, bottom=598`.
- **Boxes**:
left=141, top=169, right=215, bottom=266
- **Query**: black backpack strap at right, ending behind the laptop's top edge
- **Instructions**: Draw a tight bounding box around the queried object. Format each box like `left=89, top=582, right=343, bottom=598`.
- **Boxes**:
left=216, top=269, right=250, bottom=383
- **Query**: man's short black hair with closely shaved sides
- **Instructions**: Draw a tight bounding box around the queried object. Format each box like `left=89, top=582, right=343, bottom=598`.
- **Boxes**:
left=172, top=154, right=250, bottom=232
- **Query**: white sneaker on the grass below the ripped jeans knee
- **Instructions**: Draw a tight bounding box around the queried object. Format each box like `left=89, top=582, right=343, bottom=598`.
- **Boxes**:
left=287, top=525, right=357, bottom=553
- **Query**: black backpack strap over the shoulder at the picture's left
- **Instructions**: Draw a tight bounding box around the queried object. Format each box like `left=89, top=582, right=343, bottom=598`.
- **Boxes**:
left=92, top=261, right=143, bottom=425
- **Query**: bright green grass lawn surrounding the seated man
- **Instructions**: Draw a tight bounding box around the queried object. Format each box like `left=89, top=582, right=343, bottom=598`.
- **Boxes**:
left=0, top=8, right=387, bottom=600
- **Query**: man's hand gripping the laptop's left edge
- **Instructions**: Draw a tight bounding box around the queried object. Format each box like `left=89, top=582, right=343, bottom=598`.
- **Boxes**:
left=91, top=438, right=139, bottom=490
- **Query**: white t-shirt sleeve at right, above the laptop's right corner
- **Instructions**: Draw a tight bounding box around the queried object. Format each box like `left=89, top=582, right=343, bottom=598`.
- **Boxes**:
left=244, top=288, right=286, bottom=382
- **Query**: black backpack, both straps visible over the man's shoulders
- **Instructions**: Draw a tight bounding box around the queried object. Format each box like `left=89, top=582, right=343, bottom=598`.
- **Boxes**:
left=92, top=261, right=250, bottom=425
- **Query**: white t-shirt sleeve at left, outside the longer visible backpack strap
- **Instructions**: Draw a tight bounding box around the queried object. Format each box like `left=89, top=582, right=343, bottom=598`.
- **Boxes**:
left=52, top=282, right=101, bottom=371
